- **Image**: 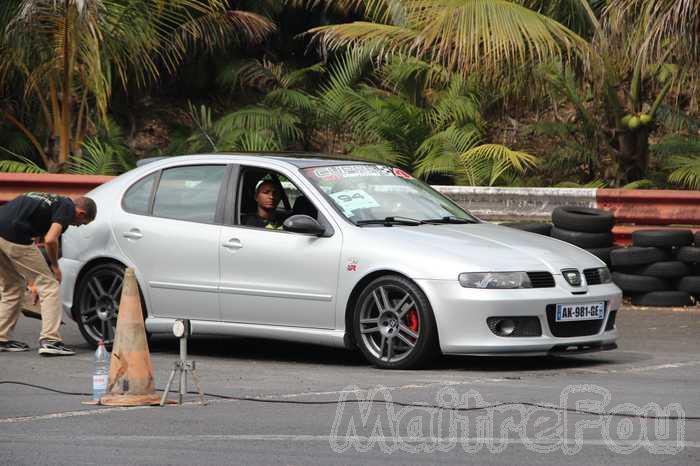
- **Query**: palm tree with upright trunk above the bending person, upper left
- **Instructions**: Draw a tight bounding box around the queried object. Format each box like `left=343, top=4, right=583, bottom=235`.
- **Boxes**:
left=0, top=0, right=273, bottom=171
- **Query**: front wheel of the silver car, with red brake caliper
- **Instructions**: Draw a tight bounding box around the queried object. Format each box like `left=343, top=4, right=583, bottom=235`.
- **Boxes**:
left=353, top=275, right=438, bottom=369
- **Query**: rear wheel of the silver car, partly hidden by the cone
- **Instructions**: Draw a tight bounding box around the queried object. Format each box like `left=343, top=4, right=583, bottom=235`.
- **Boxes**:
left=73, top=262, right=134, bottom=347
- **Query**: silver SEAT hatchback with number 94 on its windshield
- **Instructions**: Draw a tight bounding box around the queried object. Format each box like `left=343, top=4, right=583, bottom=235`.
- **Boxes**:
left=61, top=154, right=622, bottom=369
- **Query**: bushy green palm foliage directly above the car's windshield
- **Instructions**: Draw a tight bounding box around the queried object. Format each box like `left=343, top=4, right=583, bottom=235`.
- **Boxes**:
left=318, top=48, right=537, bottom=185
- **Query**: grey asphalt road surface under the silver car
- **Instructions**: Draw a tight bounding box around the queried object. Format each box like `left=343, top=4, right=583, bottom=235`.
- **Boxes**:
left=0, top=307, right=700, bottom=466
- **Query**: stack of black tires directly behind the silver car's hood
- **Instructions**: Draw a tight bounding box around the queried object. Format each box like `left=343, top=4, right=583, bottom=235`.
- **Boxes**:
left=551, top=206, right=616, bottom=265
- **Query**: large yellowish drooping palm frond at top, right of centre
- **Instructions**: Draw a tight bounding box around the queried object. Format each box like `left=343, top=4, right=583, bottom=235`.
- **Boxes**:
left=311, top=0, right=587, bottom=72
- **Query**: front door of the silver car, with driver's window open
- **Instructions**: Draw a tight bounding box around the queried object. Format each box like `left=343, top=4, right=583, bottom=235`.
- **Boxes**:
left=219, top=166, right=342, bottom=328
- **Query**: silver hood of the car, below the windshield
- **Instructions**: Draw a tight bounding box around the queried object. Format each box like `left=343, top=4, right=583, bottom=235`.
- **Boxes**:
left=362, top=223, right=605, bottom=278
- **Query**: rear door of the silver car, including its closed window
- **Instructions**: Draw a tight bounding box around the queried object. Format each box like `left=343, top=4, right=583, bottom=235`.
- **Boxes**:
left=113, top=165, right=229, bottom=320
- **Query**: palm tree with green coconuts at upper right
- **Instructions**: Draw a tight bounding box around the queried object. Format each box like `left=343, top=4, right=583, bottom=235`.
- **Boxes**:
left=312, top=0, right=700, bottom=184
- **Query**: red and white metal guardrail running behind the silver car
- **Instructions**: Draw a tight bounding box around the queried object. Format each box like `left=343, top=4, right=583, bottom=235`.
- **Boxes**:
left=0, top=173, right=700, bottom=244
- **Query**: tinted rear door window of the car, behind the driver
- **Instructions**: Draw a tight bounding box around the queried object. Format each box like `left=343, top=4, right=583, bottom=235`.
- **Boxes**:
left=153, top=165, right=226, bottom=223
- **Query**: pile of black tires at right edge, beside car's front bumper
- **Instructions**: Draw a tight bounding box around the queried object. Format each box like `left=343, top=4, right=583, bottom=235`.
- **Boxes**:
left=610, top=230, right=700, bottom=306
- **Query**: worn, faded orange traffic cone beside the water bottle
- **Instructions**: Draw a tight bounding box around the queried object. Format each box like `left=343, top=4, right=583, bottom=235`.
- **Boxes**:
left=100, top=268, right=160, bottom=406
